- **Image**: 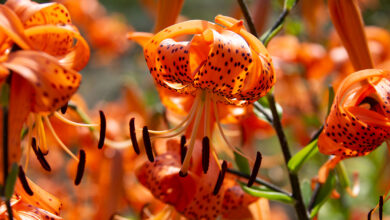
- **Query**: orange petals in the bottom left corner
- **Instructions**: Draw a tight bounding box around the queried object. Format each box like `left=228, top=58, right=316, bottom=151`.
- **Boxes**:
left=0, top=179, right=62, bottom=219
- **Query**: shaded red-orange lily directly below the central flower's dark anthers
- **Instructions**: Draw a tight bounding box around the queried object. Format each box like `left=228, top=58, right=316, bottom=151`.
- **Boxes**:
left=136, top=141, right=258, bottom=219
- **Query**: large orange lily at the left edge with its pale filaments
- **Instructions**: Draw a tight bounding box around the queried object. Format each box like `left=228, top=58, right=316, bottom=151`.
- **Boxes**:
left=0, top=0, right=89, bottom=186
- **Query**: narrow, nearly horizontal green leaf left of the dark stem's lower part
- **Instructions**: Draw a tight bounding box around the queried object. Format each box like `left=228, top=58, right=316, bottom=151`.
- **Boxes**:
left=240, top=183, right=294, bottom=203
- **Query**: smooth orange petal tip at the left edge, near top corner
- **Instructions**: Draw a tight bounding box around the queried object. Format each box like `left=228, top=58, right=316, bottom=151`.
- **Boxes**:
left=0, top=5, right=30, bottom=49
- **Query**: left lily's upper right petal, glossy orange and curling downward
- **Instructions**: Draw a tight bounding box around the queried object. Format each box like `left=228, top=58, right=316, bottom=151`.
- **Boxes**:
left=25, top=25, right=90, bottom=71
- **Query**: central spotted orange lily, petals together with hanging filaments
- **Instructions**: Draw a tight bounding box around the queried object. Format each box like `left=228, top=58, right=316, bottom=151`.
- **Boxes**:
left=129, top=15, right=275, bottom=176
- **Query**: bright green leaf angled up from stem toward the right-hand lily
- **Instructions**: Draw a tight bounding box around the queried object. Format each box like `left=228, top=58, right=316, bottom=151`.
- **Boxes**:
left=287, top=139, right=318, bottom=173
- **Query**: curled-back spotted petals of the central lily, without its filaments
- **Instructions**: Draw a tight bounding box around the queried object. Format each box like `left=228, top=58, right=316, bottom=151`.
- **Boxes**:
left=137, top=16, right=275, bottom=105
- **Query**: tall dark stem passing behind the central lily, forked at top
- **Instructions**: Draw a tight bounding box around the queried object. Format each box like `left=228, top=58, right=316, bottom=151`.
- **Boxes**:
left=238, top=0, right=309, bottom=220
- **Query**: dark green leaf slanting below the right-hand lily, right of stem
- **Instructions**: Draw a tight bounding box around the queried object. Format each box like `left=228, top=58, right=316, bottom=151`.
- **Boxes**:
left=310, top=172, right=336, bottom=218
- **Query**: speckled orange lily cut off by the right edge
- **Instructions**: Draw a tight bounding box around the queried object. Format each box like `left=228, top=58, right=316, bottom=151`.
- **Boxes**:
left=318, top=69, right=390, bottom=182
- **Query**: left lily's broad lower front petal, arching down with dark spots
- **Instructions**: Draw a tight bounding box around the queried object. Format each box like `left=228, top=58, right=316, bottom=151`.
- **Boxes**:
left=3, top=51, right=81, bottom=112
